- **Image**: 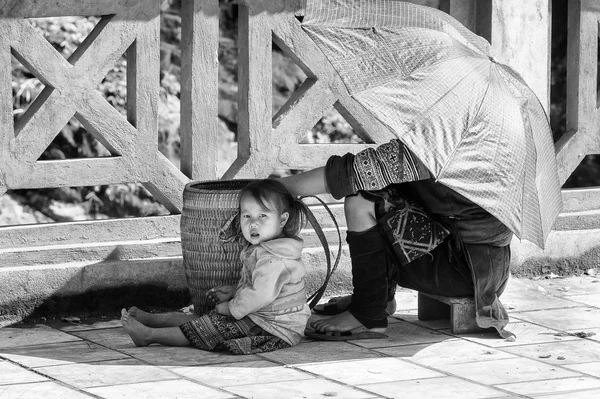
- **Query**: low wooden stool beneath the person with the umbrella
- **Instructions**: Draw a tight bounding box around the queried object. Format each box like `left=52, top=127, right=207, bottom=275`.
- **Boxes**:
left=417, top=292, right=486, bottom=334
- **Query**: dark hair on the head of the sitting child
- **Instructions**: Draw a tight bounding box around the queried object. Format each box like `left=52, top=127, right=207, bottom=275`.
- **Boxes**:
left=240, top=179, right=308, bottom=237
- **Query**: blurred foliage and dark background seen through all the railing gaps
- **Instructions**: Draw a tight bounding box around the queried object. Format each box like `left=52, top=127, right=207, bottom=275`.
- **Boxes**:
left=8, top=0, right=588, bottom=225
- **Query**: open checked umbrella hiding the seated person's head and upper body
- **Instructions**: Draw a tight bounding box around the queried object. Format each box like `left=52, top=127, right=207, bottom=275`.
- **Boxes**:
left=302, top=0, right=562, bottom=248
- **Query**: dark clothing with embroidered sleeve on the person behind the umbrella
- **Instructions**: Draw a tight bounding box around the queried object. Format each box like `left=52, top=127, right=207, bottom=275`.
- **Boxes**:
left=325, top=140, right=512, bottom=337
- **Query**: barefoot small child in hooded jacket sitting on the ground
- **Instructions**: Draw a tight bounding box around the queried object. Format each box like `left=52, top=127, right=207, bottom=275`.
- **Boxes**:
left=121, top=179, right=311, bottom=354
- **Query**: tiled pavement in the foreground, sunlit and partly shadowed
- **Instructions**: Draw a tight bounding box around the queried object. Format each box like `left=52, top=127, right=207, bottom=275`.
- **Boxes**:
left=0, top=276, right=600, bottom=399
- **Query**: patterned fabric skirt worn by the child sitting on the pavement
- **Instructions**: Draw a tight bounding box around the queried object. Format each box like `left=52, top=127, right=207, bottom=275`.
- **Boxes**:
left=179, top=310, right=291, bottom=355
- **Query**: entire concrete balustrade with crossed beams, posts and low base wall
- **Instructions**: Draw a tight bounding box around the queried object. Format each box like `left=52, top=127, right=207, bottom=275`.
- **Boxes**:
left=0, top=0, right=600, bottom=325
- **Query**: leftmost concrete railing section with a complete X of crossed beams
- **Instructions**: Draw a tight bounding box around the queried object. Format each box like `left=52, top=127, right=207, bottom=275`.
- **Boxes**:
left=0, top=0, right=188, bottom=213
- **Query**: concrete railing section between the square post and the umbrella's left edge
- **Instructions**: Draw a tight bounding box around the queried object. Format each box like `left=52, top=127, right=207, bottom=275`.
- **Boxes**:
left=226, top=3, right=393, bottom=177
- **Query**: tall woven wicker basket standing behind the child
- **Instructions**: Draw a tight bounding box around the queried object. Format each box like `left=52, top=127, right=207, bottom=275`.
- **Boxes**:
left=181, top=180, right=253, bottom=314
